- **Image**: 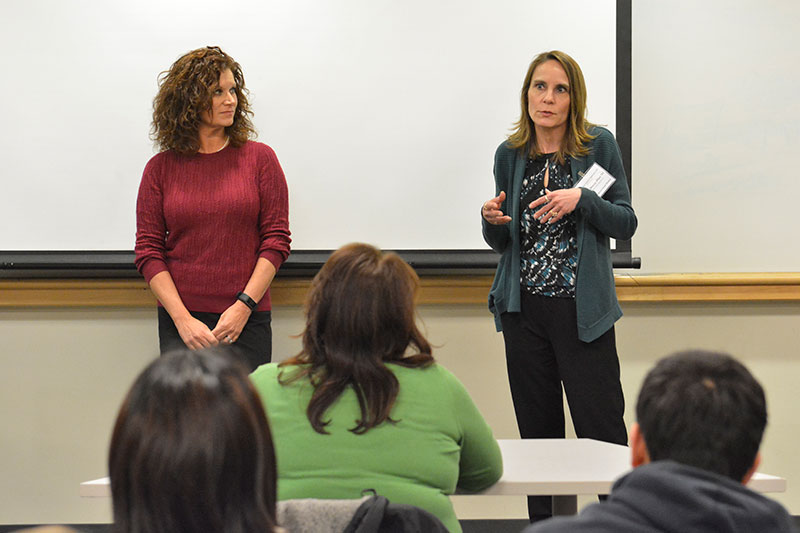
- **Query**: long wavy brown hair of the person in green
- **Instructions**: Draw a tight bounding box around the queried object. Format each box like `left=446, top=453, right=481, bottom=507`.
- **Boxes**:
left=279, top=244, right=434, bottom=434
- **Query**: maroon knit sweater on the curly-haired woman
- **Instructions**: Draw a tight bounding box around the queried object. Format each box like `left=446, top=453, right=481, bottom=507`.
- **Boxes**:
left=136, top=141, right=291, bottom=313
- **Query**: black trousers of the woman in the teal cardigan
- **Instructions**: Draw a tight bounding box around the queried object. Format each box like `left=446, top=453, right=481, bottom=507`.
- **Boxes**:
left=500, top=289, right=628, bottom=521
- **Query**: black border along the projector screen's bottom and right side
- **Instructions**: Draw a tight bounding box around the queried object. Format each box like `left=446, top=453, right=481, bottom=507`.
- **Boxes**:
left=0, top=0, right=641, bottom=279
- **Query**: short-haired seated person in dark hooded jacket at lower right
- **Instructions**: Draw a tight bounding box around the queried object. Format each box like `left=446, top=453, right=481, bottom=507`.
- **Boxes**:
left=525, top=351, right=795, bottom=533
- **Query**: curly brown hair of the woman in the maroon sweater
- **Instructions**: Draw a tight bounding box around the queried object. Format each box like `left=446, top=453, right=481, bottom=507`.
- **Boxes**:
left=150, top=46, right=256, bottom=155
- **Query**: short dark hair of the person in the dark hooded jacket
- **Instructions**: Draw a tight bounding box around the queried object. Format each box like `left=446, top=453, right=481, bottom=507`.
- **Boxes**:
left=636, top=350, right=767, bottom=482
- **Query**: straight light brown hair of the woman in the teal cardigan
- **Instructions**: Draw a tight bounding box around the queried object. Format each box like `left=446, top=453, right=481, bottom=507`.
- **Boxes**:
left=508, top=50, right=595, bottom=164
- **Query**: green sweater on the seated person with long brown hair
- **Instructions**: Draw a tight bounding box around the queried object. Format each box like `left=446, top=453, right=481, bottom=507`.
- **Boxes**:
left=251, top=363, right=503, bottom=532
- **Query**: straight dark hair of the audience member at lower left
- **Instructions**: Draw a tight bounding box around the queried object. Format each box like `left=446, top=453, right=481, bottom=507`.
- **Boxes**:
left=108, top=349, right=276, bottom=533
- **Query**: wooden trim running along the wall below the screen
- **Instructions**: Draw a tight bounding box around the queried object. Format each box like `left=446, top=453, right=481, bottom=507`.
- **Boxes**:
left=0, top=272, right=800, bottom=309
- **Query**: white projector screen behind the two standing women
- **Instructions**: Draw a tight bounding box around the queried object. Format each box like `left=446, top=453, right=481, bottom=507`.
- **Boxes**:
left=0, top=0, right=616, bottom=251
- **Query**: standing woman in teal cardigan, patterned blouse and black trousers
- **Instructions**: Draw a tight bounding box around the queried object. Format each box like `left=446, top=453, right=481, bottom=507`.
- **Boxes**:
left=481, top=51, right=637, bottom=521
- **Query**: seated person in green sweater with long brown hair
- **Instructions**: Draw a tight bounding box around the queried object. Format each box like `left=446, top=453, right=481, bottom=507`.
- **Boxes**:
left=251, top=244, right=502, bottom=532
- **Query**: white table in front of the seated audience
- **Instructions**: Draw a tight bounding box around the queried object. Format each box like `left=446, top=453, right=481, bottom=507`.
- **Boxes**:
left=80, top=439, right=786, bottom=514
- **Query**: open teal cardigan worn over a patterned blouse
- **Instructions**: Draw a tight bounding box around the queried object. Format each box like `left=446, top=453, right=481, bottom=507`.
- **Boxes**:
left=482, top=126, right=637, bottom=342
